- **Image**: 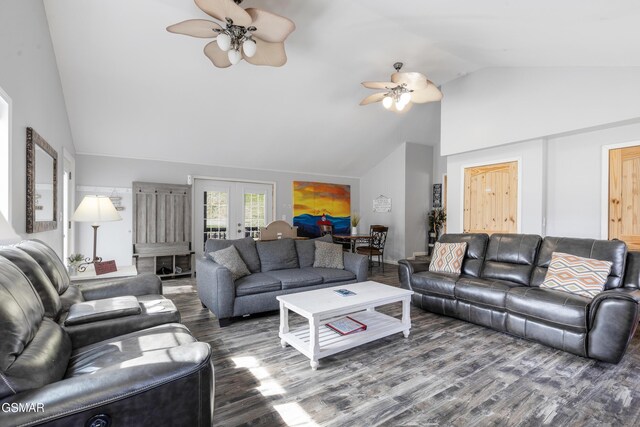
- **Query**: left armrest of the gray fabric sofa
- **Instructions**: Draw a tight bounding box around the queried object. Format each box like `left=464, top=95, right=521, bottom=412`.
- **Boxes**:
left=196, top=257, right=236, bottom=320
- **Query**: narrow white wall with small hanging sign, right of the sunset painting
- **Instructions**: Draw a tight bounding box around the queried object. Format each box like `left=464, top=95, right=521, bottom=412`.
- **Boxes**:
left=358, top=144, right=407, bottom=262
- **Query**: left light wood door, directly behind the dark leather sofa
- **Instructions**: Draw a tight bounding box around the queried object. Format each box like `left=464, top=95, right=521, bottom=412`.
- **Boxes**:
left=463, top=162, right=518, bottom=234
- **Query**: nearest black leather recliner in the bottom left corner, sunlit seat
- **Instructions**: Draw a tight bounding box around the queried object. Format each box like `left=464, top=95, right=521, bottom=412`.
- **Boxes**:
left=0, top=256, right=213, bottom=426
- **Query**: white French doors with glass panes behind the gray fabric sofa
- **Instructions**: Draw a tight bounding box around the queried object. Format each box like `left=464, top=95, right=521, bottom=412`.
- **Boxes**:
left=194, top=179, right=273, bottom=255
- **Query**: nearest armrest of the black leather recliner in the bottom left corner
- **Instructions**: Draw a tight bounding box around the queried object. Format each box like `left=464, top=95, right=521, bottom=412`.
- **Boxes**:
left=0, top=342, right=214, bottom=426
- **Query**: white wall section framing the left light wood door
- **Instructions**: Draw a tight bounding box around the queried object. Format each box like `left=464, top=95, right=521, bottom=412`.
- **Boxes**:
left=447, top=140, right=546, bottom=234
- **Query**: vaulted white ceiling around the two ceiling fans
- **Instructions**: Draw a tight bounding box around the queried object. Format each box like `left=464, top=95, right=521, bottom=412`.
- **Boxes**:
left=45, top=0, right=640, bottom=176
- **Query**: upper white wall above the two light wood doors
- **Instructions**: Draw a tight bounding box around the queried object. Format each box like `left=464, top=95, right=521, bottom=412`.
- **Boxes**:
left=442, top=67, right=640, bottom=156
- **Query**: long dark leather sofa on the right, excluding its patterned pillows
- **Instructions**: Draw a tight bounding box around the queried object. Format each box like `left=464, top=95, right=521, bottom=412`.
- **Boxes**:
left=399, top=234, right=640, bottom=363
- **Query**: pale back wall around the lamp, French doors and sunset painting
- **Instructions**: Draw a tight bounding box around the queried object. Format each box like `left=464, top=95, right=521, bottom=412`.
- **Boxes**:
left=75, top=154, right=360, bottom=264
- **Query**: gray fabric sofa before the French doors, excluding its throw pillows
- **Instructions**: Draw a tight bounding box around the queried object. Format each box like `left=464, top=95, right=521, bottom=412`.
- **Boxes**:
left=196, top=236, right=368, bottom=326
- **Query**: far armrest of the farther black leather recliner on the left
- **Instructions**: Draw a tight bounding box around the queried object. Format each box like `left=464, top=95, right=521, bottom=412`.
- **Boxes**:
left=77, top=273, right=162, bottom=301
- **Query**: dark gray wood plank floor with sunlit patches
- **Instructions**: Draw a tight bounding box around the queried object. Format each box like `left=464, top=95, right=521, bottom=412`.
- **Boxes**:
left=165, top=265, right=640, bottom=426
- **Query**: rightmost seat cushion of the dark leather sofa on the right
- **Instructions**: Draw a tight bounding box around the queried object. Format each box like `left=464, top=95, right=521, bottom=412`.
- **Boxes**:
left=506, top=286, right=591, bottom=332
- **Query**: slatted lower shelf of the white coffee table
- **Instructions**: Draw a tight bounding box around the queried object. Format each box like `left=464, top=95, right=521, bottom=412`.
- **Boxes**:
left=280, top=310, right=411, bottom=369
